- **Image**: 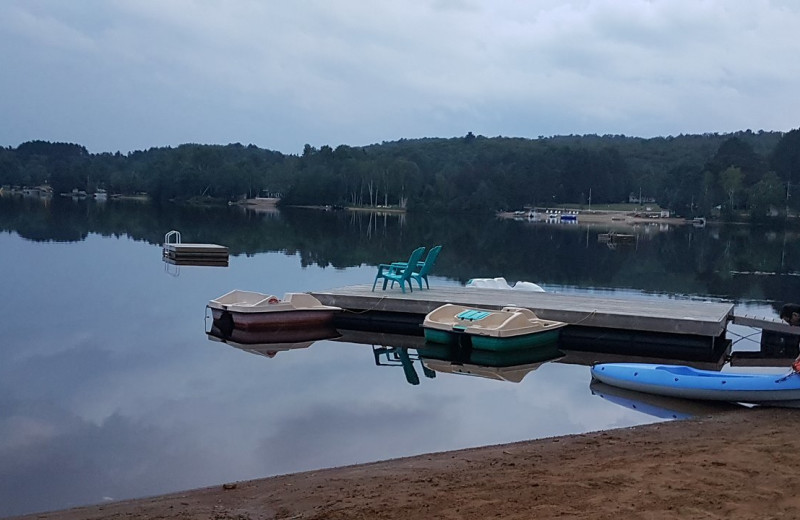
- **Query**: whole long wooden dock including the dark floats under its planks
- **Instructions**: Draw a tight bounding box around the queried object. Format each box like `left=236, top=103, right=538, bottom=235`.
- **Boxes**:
left=311, top=284, right=733, bottom=351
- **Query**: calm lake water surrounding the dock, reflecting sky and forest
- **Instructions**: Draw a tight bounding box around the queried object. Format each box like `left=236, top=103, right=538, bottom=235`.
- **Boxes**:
left=0, top=198, right=800, bottom=516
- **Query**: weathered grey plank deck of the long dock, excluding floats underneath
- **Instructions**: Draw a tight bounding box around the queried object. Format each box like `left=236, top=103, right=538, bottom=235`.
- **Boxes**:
left=311, top=284, right=733, bottom=337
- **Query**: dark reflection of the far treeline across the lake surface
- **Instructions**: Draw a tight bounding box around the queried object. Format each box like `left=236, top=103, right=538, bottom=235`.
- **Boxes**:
left=0, top=197, right=800, bottom=310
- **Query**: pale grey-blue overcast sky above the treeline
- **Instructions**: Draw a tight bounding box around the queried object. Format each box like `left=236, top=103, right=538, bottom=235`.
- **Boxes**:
left=0, top=0, right=800, bottom=154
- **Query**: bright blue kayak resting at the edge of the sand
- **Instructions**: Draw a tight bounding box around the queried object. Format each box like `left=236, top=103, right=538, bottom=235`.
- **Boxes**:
left=592, top=363, right=800, bottom=407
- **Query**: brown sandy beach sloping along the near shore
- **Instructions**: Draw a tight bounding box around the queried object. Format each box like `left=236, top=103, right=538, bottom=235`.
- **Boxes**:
left=15, top=408, right=800, bottom=520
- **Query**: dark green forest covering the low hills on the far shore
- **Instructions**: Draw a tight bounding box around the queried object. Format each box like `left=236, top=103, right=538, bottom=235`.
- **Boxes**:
left=0, top=129, right=800, bottom=220
